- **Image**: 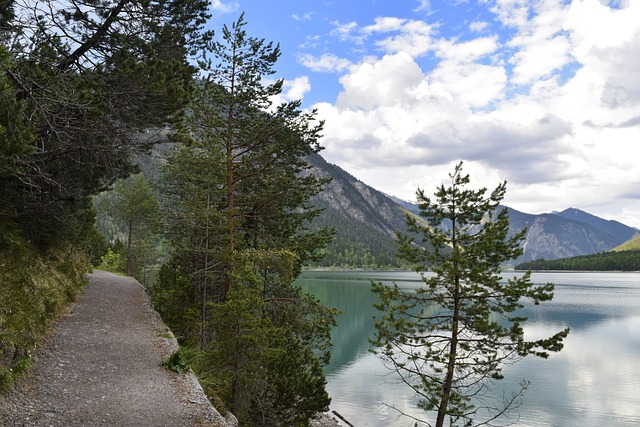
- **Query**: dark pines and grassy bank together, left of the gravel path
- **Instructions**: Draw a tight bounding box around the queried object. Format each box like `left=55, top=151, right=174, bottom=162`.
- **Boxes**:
left=0, top=0, right=208, bottom=392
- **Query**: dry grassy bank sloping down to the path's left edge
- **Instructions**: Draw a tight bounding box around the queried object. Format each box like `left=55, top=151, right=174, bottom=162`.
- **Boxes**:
left=0, top=244, right=88, bottom=389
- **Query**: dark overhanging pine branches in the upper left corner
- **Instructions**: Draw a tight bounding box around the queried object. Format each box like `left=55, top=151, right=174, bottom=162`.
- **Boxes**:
left=0, top=0, right=208, bottom=247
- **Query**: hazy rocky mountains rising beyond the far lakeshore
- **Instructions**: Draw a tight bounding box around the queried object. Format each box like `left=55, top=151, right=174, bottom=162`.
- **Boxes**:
left=309, top=155, right=639, bottom=267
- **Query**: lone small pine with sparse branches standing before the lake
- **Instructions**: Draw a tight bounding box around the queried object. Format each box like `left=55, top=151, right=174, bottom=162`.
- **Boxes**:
left=373, top=163, right=569, bottom=427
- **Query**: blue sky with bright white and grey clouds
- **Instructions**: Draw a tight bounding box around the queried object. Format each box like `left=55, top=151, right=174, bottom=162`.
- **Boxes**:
left=209, top=0, right=640, bottom=228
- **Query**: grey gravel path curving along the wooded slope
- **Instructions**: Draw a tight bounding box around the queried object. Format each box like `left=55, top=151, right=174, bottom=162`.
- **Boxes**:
left=0, top=271, right=234, bottom=427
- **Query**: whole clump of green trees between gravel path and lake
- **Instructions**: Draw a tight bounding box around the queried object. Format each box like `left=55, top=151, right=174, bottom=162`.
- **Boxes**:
left=151, top=17, right=335, bottom=426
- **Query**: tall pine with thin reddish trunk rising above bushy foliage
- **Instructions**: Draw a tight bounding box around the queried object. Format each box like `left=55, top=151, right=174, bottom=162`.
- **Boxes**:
left=195, top=15, right=329, bottom=300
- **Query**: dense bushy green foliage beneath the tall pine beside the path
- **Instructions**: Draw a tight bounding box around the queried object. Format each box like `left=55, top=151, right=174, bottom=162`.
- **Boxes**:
left=208, top=251, right=335, bottom=427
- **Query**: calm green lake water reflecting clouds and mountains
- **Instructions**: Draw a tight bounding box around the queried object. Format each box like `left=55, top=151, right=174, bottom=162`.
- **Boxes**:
left=298, top=271, right=640, bottom=427
